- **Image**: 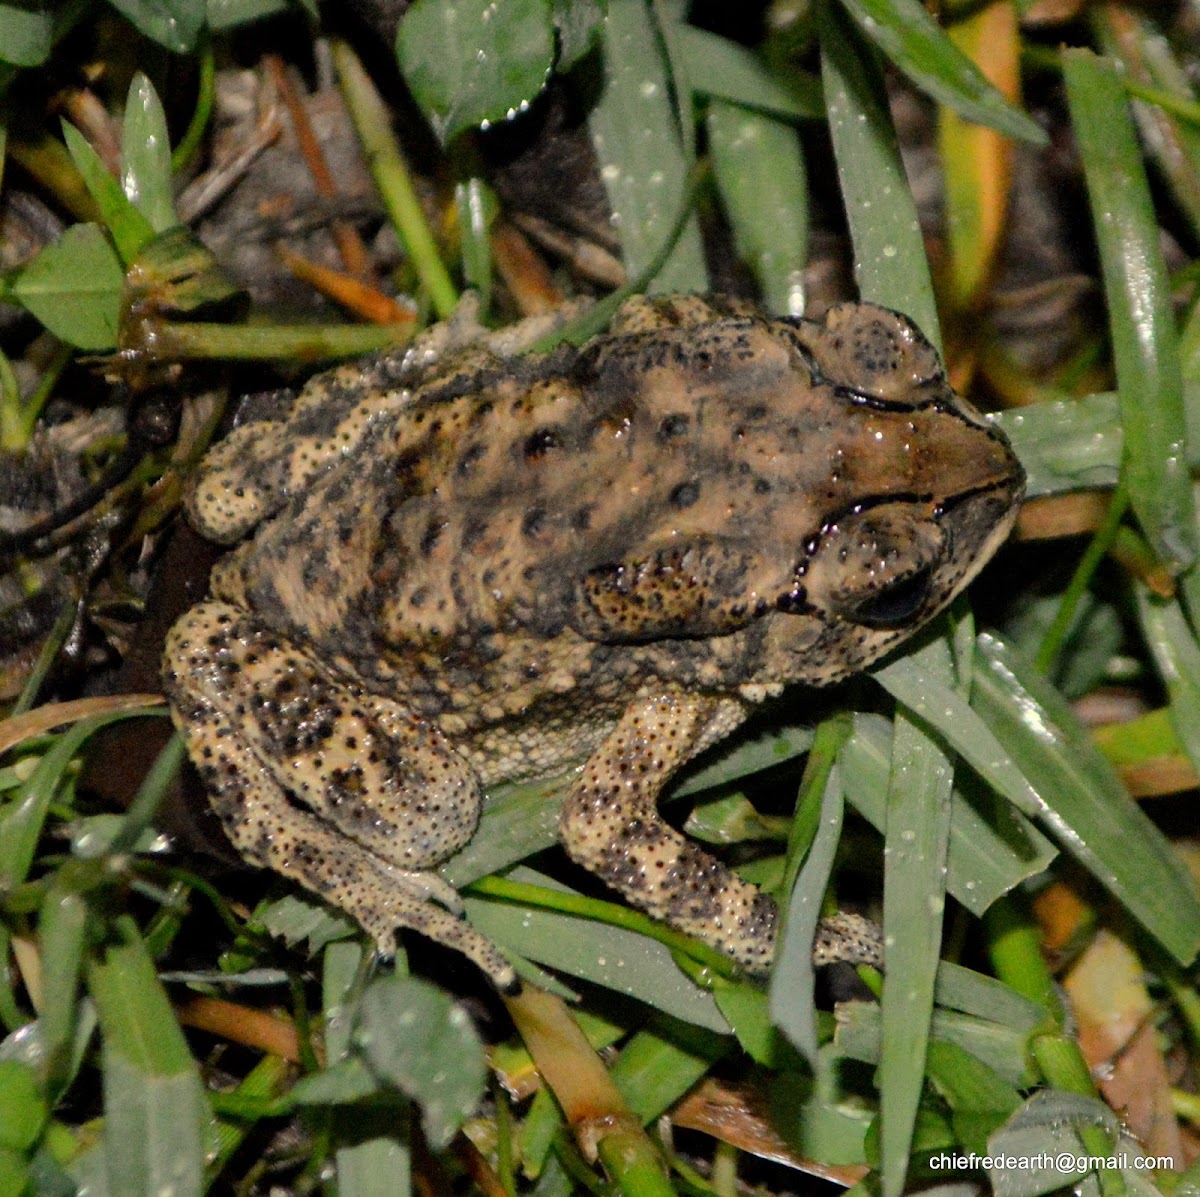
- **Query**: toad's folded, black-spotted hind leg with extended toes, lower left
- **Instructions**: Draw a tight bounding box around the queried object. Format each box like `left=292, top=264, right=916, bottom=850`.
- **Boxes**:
left=163, top=602, right=517, bottom=992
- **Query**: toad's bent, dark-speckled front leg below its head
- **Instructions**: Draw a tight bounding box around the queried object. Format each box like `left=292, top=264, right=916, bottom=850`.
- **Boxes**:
left=559, top=687, right=778, bottom=973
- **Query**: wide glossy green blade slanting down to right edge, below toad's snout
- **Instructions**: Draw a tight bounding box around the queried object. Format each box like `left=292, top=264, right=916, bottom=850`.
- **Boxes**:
left=972, top=634, right=1200, bottom=964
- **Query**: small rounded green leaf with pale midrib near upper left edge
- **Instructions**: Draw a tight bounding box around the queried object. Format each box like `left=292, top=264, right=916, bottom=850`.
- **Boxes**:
left=11, top=224, right=125, bottom=350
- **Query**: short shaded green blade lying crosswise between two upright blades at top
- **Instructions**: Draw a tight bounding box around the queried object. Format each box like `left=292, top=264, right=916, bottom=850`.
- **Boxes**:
left=678, top=25, right=826, bottom=120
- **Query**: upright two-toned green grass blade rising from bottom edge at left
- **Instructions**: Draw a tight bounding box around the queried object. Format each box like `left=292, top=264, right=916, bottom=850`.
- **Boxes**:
left=88, top=924, right=209, bottom=1197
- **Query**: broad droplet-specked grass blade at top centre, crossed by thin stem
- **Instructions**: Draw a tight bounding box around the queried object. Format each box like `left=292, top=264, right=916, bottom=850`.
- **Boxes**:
left=588, top=0, right=708, bottom=291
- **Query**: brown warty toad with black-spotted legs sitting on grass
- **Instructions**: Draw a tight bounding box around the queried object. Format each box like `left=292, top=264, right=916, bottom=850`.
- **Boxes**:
left=164, top=296, right=1024, bottom=990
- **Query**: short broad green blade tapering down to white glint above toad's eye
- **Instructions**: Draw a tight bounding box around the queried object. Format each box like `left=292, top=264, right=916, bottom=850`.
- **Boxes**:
left=706, top=100, right=809, bottom=315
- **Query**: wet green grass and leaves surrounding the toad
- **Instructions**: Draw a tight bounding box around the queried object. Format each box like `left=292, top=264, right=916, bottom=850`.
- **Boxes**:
left=0, top=0, right=1200, bottom=1197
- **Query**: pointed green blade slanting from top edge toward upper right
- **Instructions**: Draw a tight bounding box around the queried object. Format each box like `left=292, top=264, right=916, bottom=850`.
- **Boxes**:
left=841, top=0, right=1046, bottom=145
